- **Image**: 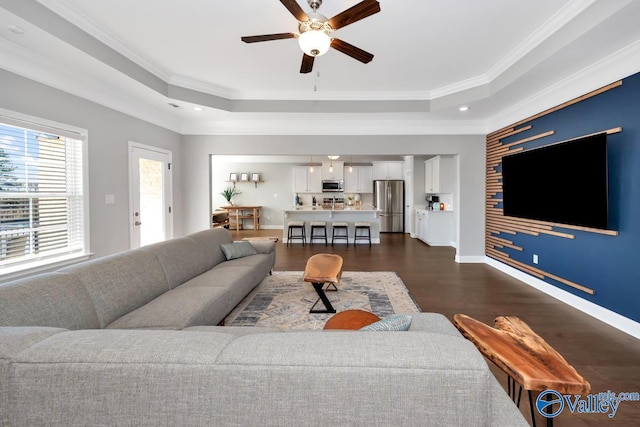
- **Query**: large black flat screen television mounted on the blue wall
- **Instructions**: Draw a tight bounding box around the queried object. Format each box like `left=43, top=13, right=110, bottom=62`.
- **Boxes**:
left=502, top=133, right=609, bottom=229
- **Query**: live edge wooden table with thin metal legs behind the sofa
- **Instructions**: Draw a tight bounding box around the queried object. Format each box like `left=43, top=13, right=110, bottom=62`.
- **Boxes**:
left=453, top=314, right=591, bottom=427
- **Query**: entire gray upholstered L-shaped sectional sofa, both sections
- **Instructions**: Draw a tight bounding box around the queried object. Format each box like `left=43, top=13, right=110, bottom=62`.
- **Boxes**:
left=0, top=229, right=526, bottom=426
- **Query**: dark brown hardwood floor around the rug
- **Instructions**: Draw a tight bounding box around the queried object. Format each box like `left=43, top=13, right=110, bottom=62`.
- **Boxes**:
left=232, top=230, right=640, bottom=427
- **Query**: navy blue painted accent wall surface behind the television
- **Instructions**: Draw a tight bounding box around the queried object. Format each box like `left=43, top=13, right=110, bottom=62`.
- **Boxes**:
left=498, top=73, right=640, bottom=322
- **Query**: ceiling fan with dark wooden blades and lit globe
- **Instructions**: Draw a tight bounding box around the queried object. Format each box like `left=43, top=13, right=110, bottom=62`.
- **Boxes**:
left=241, top=0, right=380, bottom=73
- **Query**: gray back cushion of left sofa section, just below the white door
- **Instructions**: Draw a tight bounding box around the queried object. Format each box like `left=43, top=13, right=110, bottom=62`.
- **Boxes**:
left=140, top=237, right=211, bottom=289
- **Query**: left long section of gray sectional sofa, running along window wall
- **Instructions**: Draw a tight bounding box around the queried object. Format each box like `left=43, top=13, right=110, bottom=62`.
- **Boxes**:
left=0, top=228, right=275, bottom=329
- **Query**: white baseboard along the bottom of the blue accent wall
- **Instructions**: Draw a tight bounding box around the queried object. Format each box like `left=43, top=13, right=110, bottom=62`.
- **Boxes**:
left=485, top=257, right=640, bottom=339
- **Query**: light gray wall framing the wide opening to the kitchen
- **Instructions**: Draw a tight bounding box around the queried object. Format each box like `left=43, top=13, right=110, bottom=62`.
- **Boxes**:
left=182, top=135, right=485, bottom=261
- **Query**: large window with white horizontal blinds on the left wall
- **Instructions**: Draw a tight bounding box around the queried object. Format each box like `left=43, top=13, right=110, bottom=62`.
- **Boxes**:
left=0, top=111, right=88, bottom=276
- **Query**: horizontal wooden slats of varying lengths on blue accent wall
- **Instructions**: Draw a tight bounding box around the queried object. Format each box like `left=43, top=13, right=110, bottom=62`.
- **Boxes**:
left=485, top=81, right=622, bottom=295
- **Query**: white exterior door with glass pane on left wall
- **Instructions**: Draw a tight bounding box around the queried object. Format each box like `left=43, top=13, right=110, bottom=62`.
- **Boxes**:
left=129, top=142, right=173, bottom=249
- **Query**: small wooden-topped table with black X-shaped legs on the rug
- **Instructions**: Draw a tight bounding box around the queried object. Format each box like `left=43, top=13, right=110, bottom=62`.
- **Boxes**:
left=303, top=254, right=343, bottom=313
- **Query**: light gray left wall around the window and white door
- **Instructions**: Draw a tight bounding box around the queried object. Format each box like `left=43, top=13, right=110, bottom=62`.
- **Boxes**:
left=0, top=70, right=185, bottom=256
